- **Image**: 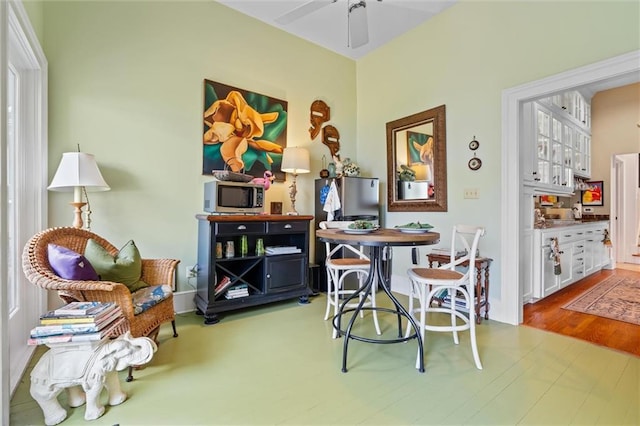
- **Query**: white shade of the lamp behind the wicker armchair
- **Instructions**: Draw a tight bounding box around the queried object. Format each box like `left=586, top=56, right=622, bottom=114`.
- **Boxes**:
left=47, top=152, right=111, bottom=192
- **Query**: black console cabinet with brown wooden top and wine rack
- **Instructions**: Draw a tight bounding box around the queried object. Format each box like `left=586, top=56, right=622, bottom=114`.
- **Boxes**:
left=195, top=215, right=313, bottom=324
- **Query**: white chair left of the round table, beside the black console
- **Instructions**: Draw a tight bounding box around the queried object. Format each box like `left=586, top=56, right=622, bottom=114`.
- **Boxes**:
left=318, top=221, right=381, bottom=339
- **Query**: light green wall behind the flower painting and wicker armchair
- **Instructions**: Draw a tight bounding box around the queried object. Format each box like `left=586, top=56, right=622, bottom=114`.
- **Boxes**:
left=43, top=1, right=356, bottom=290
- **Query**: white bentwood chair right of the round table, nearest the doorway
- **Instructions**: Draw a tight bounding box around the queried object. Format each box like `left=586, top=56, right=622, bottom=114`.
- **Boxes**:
left=406, top=225, right=484, bottom=370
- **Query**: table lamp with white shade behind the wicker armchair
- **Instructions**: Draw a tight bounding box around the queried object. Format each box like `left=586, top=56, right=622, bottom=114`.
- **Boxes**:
left=47, top=152, right=111, bottom=228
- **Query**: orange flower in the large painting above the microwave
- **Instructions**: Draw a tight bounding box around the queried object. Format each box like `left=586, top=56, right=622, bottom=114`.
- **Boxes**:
left=203, top=90, right=282, bottom=172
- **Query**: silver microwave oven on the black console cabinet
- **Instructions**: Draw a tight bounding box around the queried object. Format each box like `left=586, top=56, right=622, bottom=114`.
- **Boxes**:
left=204, top=180, right=264, bottom=214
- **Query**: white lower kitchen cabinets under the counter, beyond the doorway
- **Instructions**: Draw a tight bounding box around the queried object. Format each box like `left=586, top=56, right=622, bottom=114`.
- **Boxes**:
left=532, top=222, right=608, bottom=300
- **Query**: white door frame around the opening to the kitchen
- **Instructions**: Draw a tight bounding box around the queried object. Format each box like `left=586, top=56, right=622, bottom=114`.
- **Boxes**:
left=496, top=50, right=640, bottom=325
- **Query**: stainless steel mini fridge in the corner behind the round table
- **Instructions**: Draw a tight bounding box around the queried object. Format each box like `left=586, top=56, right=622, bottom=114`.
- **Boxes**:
left=314, top=176, right=391, bottom=291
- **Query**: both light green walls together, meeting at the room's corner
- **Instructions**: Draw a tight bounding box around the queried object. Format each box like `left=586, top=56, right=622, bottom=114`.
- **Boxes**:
left=29, top=1, right=640, bottom=314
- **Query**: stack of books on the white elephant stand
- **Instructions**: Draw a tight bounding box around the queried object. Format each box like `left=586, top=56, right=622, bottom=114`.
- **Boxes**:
left=27, top=302, right=124, bottom=345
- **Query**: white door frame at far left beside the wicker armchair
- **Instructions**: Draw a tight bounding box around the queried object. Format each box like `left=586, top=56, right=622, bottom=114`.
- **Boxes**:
left=0, top=0, right=48, bottom=416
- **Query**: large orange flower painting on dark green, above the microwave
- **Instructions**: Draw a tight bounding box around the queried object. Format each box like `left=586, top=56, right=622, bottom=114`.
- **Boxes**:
left=202, top=80, right=287, bottom=181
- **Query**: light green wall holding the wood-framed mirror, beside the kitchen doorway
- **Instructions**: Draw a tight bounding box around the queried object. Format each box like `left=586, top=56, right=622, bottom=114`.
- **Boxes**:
left=357, top=1, right=640, bottom=305
